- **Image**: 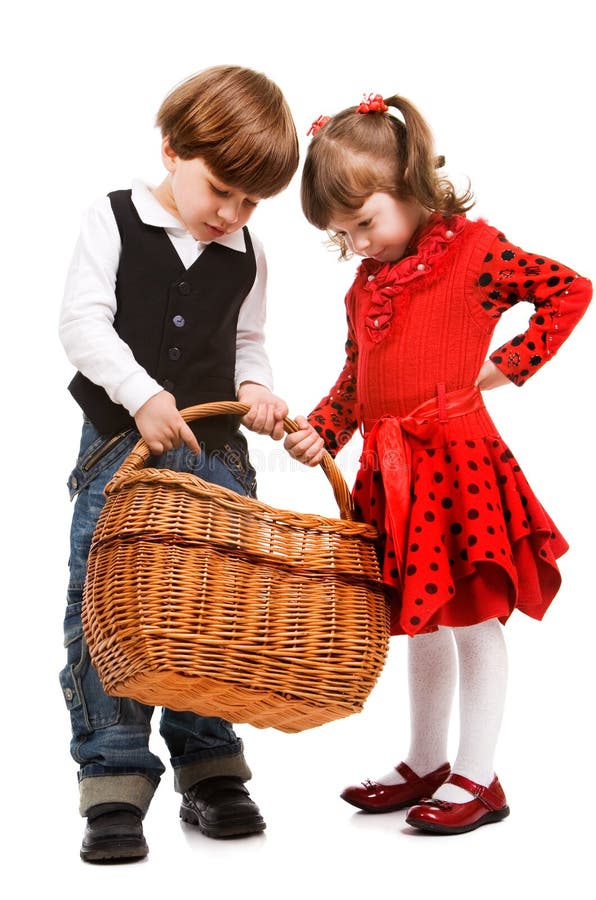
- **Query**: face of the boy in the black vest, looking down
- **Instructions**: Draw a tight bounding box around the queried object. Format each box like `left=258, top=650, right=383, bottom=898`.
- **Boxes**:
left=156, top=138, right=260, bottom=243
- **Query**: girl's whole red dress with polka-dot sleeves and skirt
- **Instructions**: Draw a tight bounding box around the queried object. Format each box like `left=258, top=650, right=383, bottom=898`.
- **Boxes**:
left=309, top=215, right=592, bottom=635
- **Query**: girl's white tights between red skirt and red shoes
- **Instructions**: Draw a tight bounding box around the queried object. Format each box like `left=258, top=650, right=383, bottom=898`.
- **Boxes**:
left=375, top=619, right=507, bottom=803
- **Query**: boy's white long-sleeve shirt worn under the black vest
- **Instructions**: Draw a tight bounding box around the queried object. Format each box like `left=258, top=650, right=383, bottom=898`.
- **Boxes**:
left=59, top=180, right=273, bottom=416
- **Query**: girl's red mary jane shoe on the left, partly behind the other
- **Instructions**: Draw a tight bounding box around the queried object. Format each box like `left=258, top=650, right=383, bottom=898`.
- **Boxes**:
left=340, top=763, right=451, bottom=812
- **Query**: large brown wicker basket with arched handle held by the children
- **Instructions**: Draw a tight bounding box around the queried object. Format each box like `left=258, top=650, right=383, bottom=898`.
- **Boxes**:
left=83, top=403, right=389, bottom=732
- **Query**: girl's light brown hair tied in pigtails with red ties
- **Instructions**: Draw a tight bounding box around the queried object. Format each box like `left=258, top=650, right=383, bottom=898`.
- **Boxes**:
left=301, top=94, right=473, bottom=258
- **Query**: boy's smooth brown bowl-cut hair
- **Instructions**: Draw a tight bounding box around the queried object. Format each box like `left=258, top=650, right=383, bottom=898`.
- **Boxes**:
left=156, top=66, right=299, bottom=197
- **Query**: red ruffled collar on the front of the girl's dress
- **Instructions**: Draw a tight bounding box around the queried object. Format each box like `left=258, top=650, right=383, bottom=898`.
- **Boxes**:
left=356, top=213, right=466, bottom=343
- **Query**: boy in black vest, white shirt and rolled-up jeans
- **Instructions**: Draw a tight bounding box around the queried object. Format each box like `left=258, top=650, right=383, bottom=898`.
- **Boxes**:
left=60, top=66, right=298, bottom=862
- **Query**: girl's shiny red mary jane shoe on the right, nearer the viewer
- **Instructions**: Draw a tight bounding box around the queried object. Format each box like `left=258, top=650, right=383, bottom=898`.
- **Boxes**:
left=406, top=774, right=509, bottom=834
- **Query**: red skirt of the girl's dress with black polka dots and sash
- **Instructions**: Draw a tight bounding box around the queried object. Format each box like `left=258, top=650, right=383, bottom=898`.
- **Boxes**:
left=353, top=389, right=568, bottom=635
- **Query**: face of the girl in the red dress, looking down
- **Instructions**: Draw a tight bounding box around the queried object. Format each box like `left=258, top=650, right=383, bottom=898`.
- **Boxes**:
left=329, top=192, right=430, bottom=262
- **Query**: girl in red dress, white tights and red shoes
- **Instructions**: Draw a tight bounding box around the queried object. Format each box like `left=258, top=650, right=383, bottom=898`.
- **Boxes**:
left=286, top=95, right=591, bottom=834
